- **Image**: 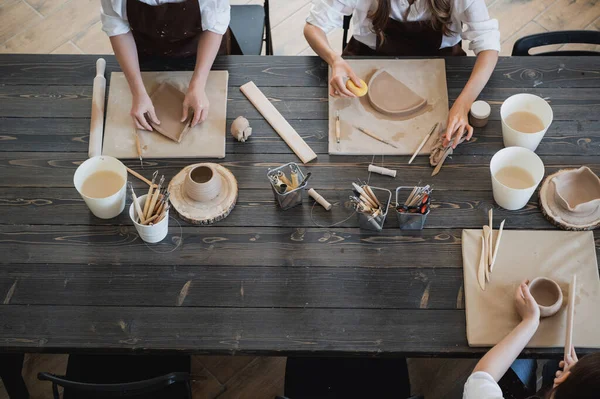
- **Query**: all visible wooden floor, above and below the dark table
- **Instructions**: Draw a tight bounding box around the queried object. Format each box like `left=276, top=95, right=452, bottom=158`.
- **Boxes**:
left=0, top=0, right=600, bottom=399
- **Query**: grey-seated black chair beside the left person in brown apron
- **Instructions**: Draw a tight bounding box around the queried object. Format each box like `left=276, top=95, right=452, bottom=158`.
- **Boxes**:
left=229, top=0, right=273, bottom=55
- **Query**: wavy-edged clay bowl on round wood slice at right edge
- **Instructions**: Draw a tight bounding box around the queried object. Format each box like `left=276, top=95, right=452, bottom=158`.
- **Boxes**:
left=540, top=166, right=600, bottom=230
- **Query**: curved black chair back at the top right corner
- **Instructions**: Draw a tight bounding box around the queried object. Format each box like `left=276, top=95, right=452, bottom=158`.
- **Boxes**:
left=512, top=30, right=600, bottom=56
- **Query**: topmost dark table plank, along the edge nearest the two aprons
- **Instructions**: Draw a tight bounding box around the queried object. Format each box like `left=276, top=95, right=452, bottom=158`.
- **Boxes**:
left=0, top=54, right=600, bottom=88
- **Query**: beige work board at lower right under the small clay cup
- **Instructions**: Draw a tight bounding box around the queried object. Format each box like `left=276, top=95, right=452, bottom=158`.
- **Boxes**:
left=462, top=230, right=600, bottom=348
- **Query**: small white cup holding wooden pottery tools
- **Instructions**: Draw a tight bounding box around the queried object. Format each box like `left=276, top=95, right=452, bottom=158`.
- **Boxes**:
left=128, top=176, right=171, bottom=244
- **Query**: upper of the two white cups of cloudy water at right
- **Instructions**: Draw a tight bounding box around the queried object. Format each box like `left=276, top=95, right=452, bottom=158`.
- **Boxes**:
left=500, top=93, right=554, bottom=151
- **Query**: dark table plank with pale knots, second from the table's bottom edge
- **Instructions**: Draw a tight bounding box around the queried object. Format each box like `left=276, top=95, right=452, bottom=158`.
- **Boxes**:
left=0, top=264, right=464, bottom=309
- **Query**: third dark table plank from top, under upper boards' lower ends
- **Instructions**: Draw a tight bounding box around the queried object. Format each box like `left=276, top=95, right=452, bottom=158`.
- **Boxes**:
left=0, top=118, right=600, bottom=159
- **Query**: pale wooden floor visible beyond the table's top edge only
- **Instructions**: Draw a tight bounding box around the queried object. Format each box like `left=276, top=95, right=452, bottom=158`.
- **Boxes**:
left=0, top=0, right=600, bottom=55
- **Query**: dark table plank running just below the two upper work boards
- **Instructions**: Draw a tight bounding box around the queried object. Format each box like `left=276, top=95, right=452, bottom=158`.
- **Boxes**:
left=0, top=152, right=600, bottom=191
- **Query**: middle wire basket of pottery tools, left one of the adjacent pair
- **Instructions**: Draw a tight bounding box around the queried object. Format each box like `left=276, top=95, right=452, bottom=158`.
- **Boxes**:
left=350, top=183, right=392, bottom=231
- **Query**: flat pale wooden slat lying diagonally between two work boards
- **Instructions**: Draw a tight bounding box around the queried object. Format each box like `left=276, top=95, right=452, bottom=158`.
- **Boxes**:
left=240, top=82, right=317, bottom=163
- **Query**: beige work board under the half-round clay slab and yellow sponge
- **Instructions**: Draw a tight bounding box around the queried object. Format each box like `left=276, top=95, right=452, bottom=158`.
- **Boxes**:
left=329, top=59, right=448, bottom=155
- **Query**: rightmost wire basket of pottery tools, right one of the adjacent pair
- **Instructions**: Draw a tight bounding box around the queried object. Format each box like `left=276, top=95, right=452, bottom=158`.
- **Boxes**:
left=396, top=185, right=433, bottom=230
